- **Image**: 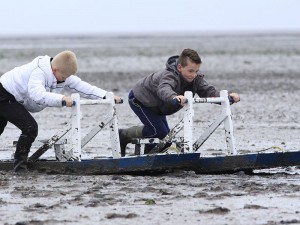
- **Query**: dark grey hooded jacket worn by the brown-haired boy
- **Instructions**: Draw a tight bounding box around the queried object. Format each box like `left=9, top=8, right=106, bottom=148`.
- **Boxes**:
left=132, top=56, right=219, bottom=115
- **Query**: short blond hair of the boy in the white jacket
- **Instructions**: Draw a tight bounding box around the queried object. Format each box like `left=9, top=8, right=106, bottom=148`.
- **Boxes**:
left=51, top=51, right=77, bottom=76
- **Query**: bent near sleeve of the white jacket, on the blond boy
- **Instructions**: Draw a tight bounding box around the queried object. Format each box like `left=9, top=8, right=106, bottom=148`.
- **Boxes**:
left=28, top=69, right=63, bottom=107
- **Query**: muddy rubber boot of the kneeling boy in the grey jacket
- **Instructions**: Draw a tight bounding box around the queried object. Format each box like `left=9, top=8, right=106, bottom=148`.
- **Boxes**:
left=119, top=126, right=144, bottom=156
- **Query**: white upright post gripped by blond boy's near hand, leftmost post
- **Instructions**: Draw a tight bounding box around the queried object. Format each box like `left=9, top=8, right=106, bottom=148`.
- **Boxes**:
left=71, top=93, right=81, bottom=162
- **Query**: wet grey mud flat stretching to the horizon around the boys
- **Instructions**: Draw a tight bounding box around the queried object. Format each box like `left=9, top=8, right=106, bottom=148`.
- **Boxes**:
left=0, top=34, right=300, bottom=225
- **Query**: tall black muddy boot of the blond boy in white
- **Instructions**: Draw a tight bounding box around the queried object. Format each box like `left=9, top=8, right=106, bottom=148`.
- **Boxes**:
left=14, top=135, right=34, bottom=173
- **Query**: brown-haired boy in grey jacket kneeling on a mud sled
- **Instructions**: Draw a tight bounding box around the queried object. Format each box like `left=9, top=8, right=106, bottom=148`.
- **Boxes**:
left=119, top=49, right=240, bottom=156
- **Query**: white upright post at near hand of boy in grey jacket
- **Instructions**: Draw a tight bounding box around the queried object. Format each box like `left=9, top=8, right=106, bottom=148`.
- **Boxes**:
left=183, top=91, right=194, bottom=152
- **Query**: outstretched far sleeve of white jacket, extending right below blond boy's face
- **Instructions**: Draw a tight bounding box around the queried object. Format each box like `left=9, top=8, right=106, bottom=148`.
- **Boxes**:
left=65, top=75, right=107, bottom=99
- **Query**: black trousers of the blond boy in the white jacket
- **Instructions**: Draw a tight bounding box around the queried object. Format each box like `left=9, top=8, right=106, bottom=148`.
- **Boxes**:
left=0, top=83, right=38, bottom=158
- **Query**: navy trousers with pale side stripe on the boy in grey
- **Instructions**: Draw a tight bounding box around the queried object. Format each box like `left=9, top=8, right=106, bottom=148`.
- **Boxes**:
left=128, top=91, right=170, bottom=139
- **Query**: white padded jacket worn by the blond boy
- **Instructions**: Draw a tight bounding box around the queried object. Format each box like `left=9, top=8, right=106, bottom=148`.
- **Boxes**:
left=0, top=55, right=106, bottom=112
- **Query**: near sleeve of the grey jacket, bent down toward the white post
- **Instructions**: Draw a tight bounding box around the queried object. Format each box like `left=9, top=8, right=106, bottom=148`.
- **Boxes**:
left=157, top=72, right=178, bottom=103
